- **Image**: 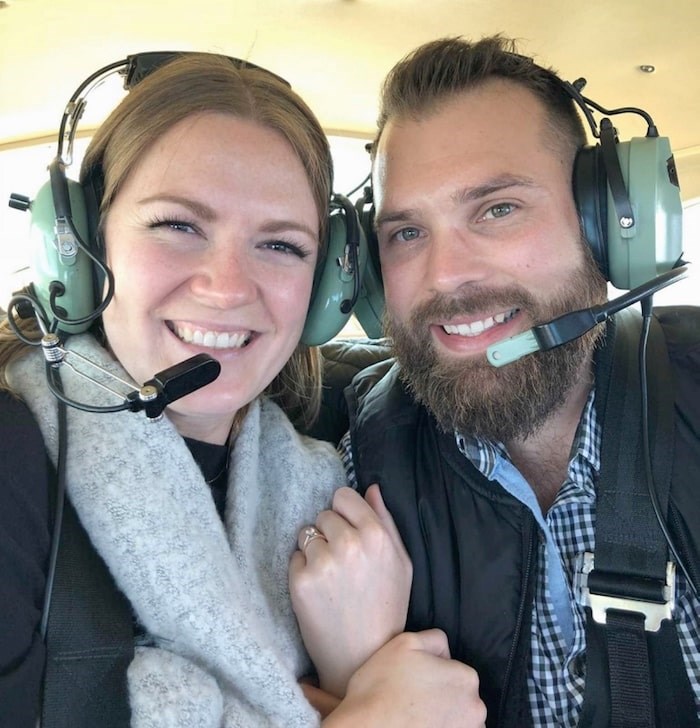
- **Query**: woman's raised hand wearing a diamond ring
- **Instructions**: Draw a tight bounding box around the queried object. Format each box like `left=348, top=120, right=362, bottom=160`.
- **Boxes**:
left=289, top=485, right=413, bottom=697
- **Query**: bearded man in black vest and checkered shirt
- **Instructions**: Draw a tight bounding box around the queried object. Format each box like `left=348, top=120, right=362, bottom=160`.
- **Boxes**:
left=348, top=37, right=700, bottom=726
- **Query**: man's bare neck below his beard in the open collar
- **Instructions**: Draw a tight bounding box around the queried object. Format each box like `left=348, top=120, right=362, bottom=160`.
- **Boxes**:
left=505, top=361, right=593, bottom=513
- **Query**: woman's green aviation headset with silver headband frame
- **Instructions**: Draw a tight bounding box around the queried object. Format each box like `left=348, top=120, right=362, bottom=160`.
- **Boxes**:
left=10, top=51, right=367, bottom=346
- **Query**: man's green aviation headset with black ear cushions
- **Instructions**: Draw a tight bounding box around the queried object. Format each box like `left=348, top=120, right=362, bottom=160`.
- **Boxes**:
left=355, top=54, right=683, bottom=336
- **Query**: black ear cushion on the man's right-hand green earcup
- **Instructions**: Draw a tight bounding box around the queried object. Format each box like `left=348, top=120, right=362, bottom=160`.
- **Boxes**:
left=572, top=144, right=610, bottom=280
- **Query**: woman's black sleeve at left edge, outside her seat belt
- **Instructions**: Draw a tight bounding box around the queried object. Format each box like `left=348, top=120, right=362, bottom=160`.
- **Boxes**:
left=0, top=391, right=50, bottom=728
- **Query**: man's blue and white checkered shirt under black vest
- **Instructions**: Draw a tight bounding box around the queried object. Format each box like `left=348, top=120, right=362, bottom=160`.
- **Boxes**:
left=339, top=390, right=700, bottom=728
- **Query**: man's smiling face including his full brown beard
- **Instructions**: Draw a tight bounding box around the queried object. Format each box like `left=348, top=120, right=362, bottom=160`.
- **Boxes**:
left=374, top=80, right=606, bottom=441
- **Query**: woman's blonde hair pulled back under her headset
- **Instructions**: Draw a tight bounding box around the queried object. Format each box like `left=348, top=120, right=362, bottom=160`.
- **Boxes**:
left=0, top=53, right=333, bottom=426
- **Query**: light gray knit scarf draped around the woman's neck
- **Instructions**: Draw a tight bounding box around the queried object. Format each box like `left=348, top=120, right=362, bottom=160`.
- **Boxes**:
left=8, top=335, right=345, bottom=728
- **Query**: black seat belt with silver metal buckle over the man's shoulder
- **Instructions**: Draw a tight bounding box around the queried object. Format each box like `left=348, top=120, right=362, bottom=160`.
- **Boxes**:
left=580, top=311, right=698, bottom=728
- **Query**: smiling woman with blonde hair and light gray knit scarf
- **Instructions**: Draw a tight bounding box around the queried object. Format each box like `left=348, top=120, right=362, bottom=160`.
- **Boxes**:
left=0, top=54, right=482, bottom=728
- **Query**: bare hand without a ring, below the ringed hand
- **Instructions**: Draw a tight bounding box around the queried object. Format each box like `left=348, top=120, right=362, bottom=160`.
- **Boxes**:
left=316, top=629, right=486, bottom=728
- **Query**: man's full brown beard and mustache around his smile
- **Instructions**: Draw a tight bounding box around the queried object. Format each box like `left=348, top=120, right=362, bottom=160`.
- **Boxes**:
left=385, top=247, right=607, bottom=442
